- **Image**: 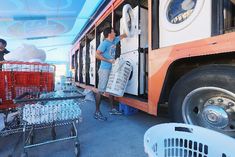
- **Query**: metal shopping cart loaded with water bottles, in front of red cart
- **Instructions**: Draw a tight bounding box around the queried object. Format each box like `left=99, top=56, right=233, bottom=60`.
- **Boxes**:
left=14, top=91, right=84, bottom=157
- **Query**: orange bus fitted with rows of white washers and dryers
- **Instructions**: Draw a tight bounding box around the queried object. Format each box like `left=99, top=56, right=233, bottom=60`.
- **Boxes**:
left=71, top=0, right=235, bottom=136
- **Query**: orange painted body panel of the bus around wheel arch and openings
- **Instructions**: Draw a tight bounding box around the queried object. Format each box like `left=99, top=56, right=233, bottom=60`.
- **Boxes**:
left=71, top=0, right=235, bottom=115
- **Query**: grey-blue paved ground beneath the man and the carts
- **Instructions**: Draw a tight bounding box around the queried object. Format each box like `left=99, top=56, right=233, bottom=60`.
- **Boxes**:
left=0, top=97, right=169, bottom=157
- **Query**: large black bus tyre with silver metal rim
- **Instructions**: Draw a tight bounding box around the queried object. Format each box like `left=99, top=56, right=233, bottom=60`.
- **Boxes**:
left=169, top=65, right=235, bottom=137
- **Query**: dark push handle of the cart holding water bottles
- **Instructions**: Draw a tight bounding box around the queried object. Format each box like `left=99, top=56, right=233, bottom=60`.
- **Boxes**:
left=13, top=95, right=85, bottom=104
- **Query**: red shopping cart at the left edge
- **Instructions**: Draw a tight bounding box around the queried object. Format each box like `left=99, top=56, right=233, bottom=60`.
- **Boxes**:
left=0, top=61, right=55, bottom=109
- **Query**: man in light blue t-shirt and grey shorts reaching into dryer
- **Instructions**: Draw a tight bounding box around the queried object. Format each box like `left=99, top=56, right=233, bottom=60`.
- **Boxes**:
left=94, top=27, right=127, bottom=121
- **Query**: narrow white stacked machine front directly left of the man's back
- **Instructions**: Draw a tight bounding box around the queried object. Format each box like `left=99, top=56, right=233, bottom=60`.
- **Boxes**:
left=89, top=39, right=96, bottom=85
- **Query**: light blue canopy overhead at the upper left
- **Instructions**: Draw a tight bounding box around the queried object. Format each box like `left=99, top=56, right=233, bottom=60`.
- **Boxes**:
left=0, top=0, right=104, bottom=61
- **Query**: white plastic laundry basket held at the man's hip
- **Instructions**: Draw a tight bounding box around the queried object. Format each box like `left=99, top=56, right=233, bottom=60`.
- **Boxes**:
left=106, top=58, right=132, bottom=97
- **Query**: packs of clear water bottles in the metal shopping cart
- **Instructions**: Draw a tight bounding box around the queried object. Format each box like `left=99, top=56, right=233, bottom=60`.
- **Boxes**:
left=22, top=92, right=81, bottom=125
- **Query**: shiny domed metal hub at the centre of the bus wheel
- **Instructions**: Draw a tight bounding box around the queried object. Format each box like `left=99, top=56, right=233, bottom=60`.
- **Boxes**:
left=202, top=105, right=229, bottom=128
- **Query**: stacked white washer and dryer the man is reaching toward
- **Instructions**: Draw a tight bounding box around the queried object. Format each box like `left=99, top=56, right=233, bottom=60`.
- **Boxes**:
left=120, top=6, right=148, bottom=95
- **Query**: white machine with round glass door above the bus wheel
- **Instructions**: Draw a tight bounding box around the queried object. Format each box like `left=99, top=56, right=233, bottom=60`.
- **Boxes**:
left=159, top=0, right=212, bottom=47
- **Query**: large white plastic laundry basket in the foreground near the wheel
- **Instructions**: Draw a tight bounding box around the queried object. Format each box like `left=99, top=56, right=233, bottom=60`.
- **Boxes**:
left=144, top=123, right=235, bottom=157
